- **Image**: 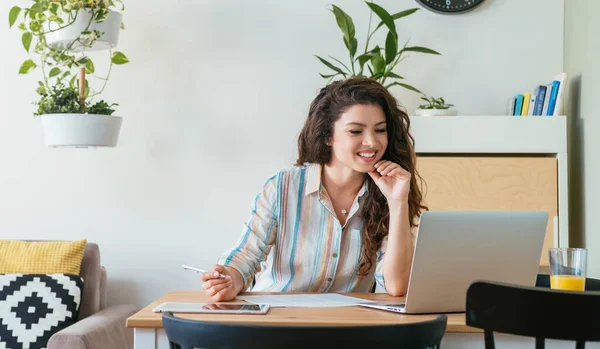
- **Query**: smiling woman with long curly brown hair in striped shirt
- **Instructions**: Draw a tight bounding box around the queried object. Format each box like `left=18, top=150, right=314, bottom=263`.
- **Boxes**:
left=202, top=78, right=426, bottom=301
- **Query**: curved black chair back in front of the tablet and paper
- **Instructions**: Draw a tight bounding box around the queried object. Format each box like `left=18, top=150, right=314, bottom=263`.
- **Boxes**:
left=162, top=312, right=448, bottom=349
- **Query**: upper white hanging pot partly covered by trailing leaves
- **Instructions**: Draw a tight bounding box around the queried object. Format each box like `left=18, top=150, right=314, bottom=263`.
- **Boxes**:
left=46, top=10, right=123, bottom=52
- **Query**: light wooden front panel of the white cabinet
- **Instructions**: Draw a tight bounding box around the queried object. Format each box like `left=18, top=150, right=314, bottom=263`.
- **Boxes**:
left=417, top=156, right=558, bottom=266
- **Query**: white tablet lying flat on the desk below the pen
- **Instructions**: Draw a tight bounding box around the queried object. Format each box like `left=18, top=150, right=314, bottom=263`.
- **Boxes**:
left=152, top=302, right=271, bottom=315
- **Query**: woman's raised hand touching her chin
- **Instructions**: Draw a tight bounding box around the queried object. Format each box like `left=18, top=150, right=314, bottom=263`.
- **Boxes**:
left=369, top=160, right=411, bottom=205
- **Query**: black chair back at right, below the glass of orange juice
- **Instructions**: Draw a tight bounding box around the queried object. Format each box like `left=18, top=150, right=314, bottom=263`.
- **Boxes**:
left=466, top=281, right=600, bottom=349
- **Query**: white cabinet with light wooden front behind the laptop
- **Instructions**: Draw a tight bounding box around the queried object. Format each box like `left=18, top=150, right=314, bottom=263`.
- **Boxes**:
left=410, top=116, right=569, bottom=270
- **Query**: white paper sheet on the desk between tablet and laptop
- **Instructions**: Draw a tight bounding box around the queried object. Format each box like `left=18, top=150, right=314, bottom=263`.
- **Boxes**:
left=237, top=293, right=372, bottom=308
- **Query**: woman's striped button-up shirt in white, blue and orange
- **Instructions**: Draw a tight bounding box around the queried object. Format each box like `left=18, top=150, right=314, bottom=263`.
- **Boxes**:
left=218, top=164, right=387, bottom=292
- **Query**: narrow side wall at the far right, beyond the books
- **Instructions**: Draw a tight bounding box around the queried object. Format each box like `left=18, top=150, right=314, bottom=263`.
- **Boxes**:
left=564, top=0, right=600, bottom=278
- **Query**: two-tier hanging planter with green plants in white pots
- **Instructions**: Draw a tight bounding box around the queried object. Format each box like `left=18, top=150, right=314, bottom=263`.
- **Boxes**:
left=8, top=0, right=129, bottom=147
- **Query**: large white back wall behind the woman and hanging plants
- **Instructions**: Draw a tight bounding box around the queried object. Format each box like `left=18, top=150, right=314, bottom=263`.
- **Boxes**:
left=0, top=0, right=564, bottom=306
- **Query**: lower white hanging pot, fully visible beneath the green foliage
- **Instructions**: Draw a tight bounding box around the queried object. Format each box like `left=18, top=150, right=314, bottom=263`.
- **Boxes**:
left=40, top=114, right=123, bottom=148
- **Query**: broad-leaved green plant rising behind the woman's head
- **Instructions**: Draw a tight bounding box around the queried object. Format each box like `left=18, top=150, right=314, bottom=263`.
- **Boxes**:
left=316, top=2, right=440, bottom=93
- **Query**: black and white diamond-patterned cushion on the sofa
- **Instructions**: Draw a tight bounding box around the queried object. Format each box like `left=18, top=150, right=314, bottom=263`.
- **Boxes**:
left=0, top=274, right=83, bottom=349
